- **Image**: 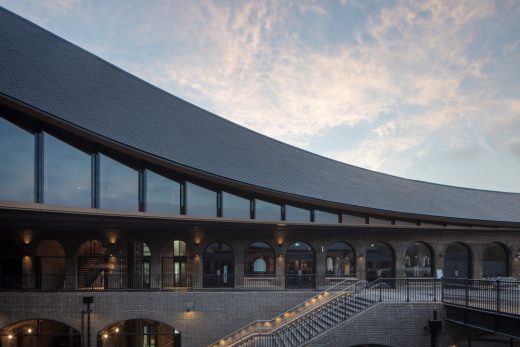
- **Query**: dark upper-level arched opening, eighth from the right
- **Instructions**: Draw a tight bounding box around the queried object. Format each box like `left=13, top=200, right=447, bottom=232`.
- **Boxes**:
left=203, top=242, right=235, bottom=288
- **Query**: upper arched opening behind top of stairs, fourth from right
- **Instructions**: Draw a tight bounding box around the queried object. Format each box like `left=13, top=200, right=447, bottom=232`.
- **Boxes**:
left=366, top=242, right=395, bottom=282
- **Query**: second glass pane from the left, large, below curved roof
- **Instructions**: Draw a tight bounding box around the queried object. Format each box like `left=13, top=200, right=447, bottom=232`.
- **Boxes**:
left=43, top=133, right=92, bottom=207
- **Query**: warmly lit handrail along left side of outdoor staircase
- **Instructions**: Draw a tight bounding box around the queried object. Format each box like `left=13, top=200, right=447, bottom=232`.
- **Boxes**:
left=210, top=278, right=366, bottom=347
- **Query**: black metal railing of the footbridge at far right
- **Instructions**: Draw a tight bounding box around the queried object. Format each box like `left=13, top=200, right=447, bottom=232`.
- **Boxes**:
left=442, top=278, right=520, bottom=315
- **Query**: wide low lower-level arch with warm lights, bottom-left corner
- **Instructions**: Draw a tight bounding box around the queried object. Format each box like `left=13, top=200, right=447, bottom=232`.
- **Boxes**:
left=0, top=319, right=81, bottom=347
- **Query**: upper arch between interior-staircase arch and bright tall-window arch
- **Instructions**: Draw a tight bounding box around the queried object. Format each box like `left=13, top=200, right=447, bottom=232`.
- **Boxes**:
left=121, top=241, right=151, bottom=289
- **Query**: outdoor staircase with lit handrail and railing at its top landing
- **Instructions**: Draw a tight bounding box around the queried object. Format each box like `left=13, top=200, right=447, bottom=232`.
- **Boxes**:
left=210, top=278, right=440, bottom=347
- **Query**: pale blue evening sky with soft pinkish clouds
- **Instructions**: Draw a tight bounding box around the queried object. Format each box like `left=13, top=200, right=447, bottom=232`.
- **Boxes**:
left=0, top=0, right=520, bottom=192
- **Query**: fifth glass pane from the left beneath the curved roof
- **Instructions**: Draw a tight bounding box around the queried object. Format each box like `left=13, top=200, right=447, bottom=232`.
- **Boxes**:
left=186, top=182, right=217, bottom=217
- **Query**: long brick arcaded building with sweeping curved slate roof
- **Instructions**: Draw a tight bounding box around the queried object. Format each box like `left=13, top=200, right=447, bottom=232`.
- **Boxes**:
left=0, top=8, right=520, bottom=346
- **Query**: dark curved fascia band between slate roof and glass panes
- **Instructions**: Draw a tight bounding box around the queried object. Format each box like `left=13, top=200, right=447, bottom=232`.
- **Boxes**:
left=4, top=93, right=520, bottom=228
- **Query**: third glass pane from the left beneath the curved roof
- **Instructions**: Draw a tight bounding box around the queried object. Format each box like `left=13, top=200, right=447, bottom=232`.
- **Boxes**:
left=99, top=154, right=139, bottom=211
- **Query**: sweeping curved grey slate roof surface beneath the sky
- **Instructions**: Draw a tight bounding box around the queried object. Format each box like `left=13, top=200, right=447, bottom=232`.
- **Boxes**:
left=0, top=7, right=520, bottom=222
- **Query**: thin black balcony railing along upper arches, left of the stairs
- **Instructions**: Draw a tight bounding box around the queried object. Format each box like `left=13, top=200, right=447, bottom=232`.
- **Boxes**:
left=0, top=276, right=356, bottom=291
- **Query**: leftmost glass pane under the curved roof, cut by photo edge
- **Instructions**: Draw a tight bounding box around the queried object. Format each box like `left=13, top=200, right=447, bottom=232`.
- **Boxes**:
left=0, top=117, right=34, bottom=202
